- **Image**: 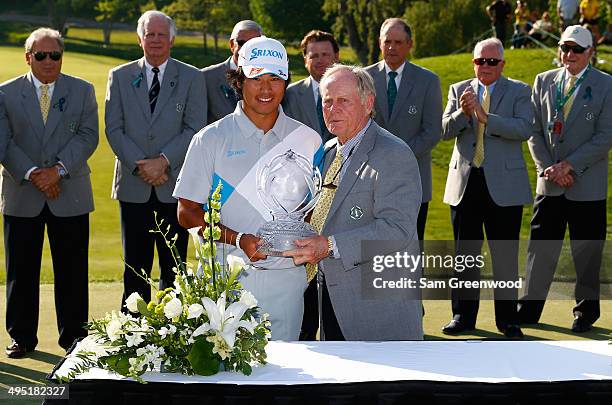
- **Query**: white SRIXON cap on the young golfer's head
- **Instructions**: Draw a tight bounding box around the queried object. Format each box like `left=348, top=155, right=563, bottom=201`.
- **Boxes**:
left=238, top=35, right=289, bottom=80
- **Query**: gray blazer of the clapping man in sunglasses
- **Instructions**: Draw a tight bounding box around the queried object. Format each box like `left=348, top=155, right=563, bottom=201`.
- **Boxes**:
left=442, top=76, right=533, bottom=207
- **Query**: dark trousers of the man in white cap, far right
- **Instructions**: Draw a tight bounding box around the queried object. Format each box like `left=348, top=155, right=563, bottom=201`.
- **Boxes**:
left=519, top=195, right=607, bottom=323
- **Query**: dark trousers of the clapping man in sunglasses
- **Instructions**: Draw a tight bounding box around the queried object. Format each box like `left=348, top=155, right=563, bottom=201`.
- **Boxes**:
left=451, top=168, right=523, bottom=327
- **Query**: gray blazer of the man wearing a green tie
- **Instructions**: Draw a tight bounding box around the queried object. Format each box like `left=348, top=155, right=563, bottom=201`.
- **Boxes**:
left=366, top=61, right=442, bottom=202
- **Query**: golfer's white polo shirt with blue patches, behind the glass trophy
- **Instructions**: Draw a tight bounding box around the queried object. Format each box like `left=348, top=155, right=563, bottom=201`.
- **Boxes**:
left=174, top=101, right=323, bottom=269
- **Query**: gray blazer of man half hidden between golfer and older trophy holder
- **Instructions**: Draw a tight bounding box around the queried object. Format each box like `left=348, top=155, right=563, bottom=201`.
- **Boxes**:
left=283, top=76, right=322, bottom=135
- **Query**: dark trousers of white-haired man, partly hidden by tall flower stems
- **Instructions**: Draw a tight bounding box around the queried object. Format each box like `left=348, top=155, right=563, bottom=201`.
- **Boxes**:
left=119, top=189, right=188, bottom=311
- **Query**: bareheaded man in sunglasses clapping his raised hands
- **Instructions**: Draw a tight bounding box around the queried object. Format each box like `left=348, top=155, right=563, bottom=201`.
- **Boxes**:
left=442, top=38, right=533, bottom=338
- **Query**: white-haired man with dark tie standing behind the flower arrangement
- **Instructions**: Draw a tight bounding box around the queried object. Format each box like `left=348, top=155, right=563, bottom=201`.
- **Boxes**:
left=105, top=10, right=206, bottom=310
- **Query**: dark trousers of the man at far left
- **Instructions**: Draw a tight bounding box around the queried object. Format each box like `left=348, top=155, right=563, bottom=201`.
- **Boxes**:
left=4, top=204, right=89, bottom=349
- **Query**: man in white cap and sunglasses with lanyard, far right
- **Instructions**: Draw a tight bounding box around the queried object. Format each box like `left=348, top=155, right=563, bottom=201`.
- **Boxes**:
left=519, top=25, right=612, bottom=333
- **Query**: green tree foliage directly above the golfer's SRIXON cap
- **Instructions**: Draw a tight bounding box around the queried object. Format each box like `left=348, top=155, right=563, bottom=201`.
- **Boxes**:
left=249, top=0, right=330, bottom=41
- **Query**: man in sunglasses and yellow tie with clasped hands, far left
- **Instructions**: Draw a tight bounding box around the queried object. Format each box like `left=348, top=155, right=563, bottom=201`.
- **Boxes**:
left=0, top=28, right=98, bottom=358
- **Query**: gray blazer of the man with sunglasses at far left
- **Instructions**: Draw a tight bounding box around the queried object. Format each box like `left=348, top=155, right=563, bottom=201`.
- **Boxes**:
left=0, top=73, right=98, bottom=218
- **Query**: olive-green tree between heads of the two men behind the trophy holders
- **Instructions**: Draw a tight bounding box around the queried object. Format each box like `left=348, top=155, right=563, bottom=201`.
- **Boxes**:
left=323, top=0, right=413, bottom=66
